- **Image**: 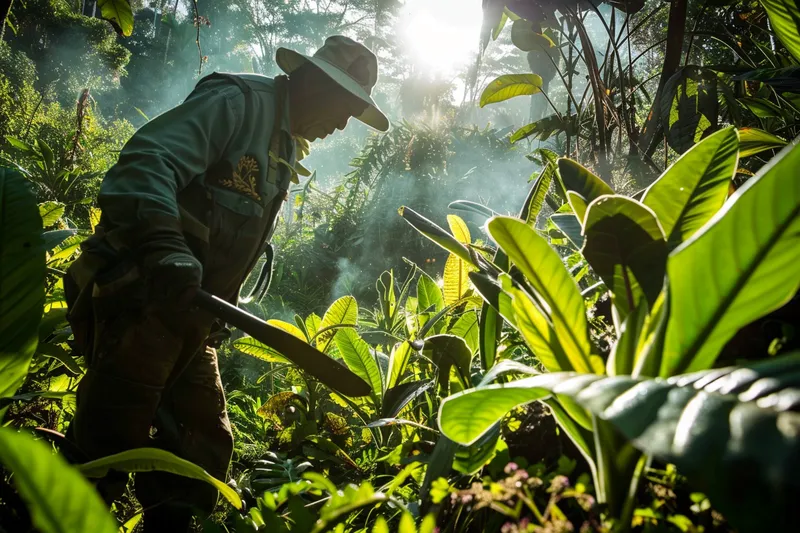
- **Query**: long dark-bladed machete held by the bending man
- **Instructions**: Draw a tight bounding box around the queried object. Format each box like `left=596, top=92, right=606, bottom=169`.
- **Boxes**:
left=194, top=290, right=372, bottom=396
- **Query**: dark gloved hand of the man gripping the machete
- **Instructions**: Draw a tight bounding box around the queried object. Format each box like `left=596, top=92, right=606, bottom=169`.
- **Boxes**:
left=143, top=249, right=203, bottom=309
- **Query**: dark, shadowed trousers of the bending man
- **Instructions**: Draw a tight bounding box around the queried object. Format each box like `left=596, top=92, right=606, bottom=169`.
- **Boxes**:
left=68, top=258, right=233, bottom=531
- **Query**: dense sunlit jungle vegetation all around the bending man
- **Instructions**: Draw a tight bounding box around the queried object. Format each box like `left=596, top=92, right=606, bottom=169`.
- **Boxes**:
left=0, top=0, right=800, bottom=533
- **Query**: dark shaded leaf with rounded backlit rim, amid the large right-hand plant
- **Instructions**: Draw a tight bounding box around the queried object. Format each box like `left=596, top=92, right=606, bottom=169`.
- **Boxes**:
left=581, top=196, right=667, bottom=318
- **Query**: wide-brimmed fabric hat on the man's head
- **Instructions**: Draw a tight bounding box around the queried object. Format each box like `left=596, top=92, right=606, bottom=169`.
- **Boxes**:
left=275, top=35, right=389, bottom=131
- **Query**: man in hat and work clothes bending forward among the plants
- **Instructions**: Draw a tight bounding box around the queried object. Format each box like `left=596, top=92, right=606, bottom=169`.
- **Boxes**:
left=65, top=36, right=389, bottom=533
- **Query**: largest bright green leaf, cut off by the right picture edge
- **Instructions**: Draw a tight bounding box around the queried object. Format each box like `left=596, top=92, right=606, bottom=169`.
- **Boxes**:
left=660, top=140, right=800, bottom=376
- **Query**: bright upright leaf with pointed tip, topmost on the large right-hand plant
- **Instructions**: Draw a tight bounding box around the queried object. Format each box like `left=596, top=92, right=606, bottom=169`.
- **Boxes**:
left=642, top=127, right=739, bottom=248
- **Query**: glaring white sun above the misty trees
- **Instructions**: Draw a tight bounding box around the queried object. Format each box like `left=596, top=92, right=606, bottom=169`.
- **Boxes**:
left=399, top=0, right=481, bottom=77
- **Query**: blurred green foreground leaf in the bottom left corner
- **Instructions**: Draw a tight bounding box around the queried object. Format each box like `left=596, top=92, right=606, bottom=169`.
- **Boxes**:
left=0, top=428, right=118, bottom=533
